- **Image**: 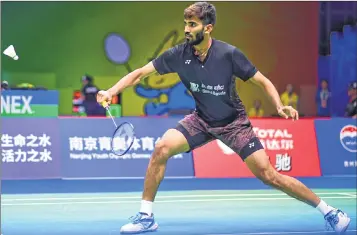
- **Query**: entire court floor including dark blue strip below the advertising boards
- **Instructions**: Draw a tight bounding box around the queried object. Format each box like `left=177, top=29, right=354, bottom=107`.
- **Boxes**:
left=1, top=177, right=357, bottom=235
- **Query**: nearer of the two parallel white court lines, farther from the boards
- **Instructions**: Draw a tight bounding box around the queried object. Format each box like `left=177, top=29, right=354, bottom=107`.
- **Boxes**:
left=1, top=196, right=351, bottom=206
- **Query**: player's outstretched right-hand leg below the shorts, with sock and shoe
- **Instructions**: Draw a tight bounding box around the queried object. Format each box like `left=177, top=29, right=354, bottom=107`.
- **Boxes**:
left=243, top=149, right=350, bottom=233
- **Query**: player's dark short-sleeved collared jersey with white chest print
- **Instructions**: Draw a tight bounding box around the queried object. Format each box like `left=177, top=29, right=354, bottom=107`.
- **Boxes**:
left=153, top=39, right=257, bottom=127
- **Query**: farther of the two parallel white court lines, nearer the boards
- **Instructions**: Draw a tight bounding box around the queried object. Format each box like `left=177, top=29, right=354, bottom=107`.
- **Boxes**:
left=2, top=192, right=352, bottom=202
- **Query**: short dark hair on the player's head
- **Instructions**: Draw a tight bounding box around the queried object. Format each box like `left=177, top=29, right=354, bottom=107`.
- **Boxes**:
left=184, top=2, right=216, bottom=25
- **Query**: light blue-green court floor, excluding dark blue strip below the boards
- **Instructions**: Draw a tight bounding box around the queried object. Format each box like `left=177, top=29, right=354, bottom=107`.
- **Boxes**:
left=1, top=189, right=357, bottom=235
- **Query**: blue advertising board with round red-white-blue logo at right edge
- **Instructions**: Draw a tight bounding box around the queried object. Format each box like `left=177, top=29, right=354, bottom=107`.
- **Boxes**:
left=315, top=118, right=357, bottom=175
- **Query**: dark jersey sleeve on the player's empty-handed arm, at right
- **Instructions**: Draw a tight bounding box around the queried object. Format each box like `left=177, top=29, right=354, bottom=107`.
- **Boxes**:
left=232, top=48, right=258, bottom=81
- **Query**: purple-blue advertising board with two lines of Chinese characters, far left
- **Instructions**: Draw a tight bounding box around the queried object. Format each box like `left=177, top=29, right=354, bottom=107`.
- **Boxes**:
left=1, top=118, right=61, bottom=179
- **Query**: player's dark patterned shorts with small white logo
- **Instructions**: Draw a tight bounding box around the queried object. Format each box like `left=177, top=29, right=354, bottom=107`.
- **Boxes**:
left=176, top=112, right=264, bottom=160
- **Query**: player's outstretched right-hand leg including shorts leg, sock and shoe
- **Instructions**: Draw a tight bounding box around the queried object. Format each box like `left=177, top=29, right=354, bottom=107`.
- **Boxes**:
left=217, top=118, right=350, bottom=232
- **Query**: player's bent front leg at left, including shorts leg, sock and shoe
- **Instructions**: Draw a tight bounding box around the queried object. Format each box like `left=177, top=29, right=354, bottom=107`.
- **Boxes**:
left=121, top=114, right=212, bottom=233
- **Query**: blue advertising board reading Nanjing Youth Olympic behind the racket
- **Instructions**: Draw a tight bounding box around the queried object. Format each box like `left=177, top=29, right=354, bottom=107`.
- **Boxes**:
left=60, top=117, right=194, bottom=178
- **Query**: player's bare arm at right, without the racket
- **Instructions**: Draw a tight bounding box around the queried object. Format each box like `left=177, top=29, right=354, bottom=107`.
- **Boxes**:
left=250, top=71, right=299, bottom=120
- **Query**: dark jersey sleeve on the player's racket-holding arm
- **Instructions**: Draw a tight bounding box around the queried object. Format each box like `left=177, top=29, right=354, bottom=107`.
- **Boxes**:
left=152, top=47, right=177, bottom=75
